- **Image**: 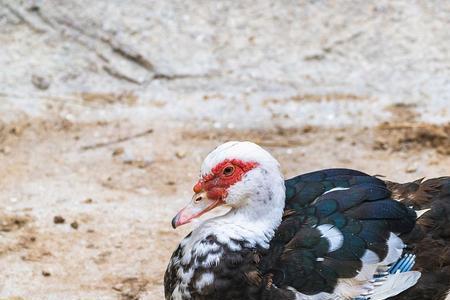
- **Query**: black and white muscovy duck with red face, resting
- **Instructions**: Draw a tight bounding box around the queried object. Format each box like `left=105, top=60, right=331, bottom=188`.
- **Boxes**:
left=164, top=142, right=450, bottom=300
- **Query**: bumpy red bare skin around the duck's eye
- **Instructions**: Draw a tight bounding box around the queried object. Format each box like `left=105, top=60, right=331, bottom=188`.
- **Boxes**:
left=193, top=159, right=258, bottom=200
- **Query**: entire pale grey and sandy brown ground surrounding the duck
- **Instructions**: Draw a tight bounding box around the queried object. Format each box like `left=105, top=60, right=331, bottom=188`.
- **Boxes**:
left=0, top=0, right=450, bottom=300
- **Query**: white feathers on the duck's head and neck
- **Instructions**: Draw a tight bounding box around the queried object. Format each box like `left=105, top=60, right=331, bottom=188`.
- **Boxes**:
left=193, top=141, right=285, bottom=246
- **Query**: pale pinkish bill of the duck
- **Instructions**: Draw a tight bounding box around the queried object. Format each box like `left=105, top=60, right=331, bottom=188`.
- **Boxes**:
left=172, top=192, right=224, bottom=229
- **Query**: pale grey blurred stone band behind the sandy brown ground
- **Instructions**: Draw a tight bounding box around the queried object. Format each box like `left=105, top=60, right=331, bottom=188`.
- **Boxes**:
left=0, top=0, right=450, bottom=127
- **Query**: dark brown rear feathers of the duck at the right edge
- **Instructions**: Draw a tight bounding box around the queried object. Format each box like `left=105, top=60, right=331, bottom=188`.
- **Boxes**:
left=387, top=177, right=450, bottom=300
